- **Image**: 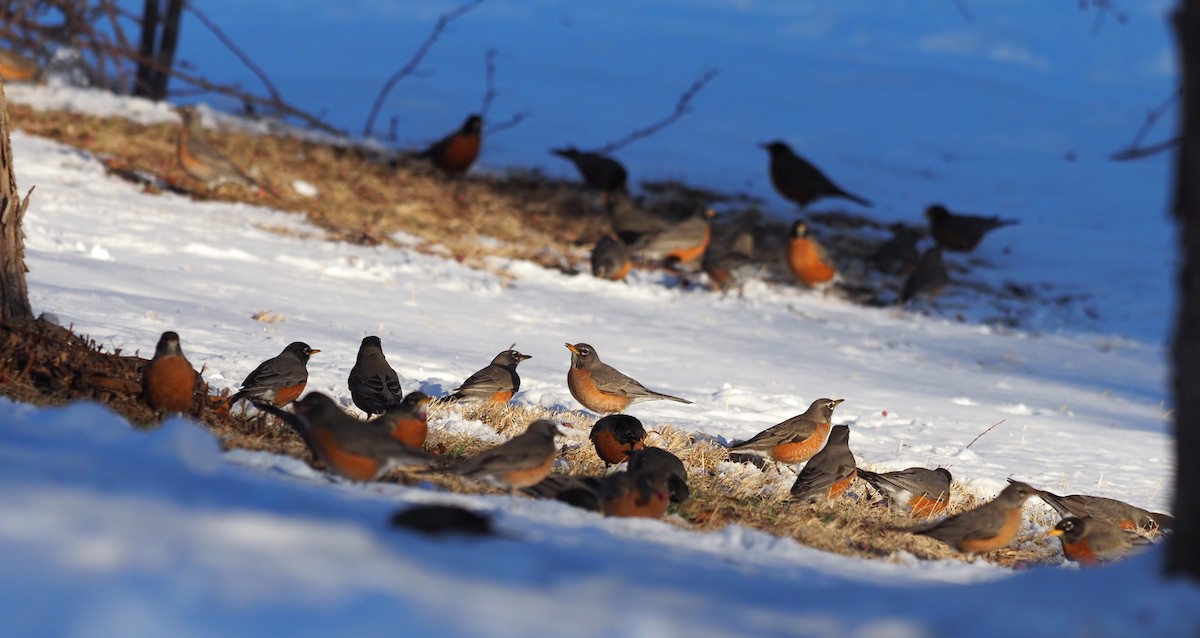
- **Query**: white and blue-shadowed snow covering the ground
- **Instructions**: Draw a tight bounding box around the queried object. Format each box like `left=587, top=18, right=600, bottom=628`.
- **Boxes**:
left=0, top=2, right=1200, bottom=637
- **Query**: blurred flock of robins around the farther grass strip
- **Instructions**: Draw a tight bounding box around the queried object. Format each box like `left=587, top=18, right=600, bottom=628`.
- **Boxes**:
left=176, top=107, right=1016, bottom=303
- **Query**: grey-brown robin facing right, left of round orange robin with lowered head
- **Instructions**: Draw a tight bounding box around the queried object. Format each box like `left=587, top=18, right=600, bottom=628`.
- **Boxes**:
left=451, top=419, right=558, bottom=490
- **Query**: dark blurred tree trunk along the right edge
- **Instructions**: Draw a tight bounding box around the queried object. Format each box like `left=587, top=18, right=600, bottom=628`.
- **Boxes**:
left=1166, top=0, right=1200, bottom=579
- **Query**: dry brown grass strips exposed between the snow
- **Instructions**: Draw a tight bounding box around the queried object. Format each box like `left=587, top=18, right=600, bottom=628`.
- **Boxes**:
left=0, top=104, right=1058, bottom=566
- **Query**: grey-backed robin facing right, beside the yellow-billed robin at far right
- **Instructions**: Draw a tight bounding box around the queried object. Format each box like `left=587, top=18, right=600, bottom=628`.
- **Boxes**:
left=898, top=481, right=1037, bottom=554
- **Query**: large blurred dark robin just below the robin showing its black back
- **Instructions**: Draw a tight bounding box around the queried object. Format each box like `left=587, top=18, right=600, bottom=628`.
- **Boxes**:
left=263, top=392, right=434, bottom=481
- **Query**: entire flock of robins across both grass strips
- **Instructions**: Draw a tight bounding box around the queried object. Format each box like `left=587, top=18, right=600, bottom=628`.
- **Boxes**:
left=0, top=62, right=1174, bottom=566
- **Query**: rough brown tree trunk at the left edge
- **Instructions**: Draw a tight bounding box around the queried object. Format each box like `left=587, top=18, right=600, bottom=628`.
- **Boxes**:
left=0, top=80, right=34, bottom=324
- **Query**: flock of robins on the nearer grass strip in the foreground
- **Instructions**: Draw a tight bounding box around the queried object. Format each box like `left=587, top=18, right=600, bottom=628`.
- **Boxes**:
left=142, top=332, right=1174, bottom=566
